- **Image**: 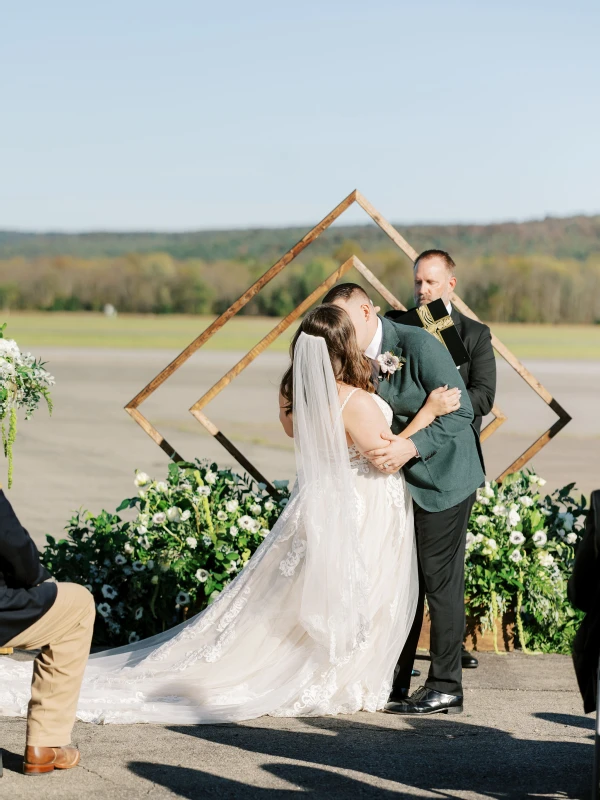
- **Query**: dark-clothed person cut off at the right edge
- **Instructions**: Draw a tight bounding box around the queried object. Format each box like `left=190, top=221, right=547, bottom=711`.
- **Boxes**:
left=568, top=490, right=600, bottom=714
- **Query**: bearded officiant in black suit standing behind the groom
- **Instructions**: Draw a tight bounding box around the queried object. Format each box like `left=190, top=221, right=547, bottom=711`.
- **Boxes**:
left=413, top=250, right=496, bottom=669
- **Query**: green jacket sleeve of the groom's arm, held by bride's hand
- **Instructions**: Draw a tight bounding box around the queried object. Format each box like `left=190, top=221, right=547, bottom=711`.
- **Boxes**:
left=410, top=334, right=473, bottom=459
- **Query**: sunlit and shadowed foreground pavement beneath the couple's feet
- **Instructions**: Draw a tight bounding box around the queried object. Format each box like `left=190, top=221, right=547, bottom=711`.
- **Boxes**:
left=0, top=654, right=594, bottom=800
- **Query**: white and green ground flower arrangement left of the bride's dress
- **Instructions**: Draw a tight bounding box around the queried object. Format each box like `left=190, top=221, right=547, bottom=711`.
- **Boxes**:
left=43, top=461, right=289, bottom=646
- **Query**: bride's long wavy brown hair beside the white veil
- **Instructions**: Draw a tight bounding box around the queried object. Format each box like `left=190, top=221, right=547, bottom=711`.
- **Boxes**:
left=280, top=303, right=375, bottom=414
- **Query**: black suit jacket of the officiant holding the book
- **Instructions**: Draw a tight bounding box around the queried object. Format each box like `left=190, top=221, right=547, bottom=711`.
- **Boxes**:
left=452, top=306, right=496, bottom=434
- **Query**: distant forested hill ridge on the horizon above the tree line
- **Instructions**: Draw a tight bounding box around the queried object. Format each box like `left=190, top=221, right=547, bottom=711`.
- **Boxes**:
left=0, top=215, right=600, bottom=262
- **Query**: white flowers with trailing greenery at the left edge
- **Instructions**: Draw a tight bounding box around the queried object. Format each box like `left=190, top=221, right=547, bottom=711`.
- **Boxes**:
left=0, top=323, right=54, bottom=489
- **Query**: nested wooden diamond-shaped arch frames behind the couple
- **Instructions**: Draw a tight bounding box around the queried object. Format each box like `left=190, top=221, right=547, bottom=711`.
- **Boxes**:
left=125, top=190, right=571, bottom=494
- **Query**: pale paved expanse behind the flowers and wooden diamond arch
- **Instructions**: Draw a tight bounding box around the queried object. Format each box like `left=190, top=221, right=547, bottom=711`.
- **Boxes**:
left=0, top=343, right=600, bottom=543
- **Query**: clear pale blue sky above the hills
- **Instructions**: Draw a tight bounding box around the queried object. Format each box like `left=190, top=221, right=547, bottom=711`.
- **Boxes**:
left=0, top=0, right=600, bottom=230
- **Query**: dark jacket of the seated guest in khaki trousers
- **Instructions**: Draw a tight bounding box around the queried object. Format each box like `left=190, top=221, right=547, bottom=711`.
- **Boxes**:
left=0, top=489, right=57, bottom=646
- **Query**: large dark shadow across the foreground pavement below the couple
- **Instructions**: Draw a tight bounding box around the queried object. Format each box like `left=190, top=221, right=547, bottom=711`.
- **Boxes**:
left=122, top=714, right=593, bottom=800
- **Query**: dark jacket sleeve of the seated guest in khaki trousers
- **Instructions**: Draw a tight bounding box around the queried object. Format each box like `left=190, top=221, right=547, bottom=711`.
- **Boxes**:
left=0, top=490, right=52, bottom=588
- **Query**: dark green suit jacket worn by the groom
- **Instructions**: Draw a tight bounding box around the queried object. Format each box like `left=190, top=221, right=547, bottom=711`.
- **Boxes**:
left=377, top=317, right=485, bottom=511
